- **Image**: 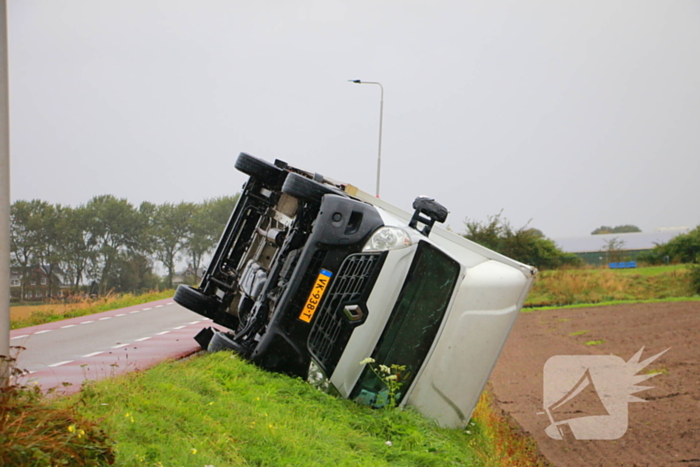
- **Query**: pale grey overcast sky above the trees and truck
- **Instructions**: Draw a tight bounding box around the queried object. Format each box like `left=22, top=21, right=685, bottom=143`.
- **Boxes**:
left=8, top=0, right=700, bottom=239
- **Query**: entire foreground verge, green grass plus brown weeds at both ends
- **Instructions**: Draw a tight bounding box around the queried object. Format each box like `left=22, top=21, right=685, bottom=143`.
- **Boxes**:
left=0, top=352, right=544, bottom=467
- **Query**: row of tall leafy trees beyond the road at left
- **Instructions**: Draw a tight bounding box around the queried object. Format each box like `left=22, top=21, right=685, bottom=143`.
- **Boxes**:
left=10, top=194, right=238, bottom=300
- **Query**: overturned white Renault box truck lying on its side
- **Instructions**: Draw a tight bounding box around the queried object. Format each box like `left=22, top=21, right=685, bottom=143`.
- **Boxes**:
left=175, top=153, right=536, bottom=427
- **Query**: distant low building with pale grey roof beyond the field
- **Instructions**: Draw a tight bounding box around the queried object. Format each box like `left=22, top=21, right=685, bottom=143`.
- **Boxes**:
left=554, top=227, right=690, bottom=266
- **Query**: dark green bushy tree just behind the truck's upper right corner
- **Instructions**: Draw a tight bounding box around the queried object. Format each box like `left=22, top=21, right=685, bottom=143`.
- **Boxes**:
left=463, top=212, right=581, bottom=269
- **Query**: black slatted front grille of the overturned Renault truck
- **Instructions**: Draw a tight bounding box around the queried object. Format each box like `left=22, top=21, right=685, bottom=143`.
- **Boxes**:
left=308, top=253, right=384, bottom=376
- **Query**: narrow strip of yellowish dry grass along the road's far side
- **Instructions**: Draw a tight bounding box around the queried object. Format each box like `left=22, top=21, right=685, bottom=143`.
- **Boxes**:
left=10, top=290, right=175, bottom=329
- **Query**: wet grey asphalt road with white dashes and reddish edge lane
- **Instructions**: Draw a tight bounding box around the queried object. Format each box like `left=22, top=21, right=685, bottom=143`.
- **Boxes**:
left=10, top=299, right=216, bottom=393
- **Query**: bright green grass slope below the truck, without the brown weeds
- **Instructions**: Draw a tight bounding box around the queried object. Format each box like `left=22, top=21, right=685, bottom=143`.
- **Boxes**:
left=66, top=352, right=490, bottom=467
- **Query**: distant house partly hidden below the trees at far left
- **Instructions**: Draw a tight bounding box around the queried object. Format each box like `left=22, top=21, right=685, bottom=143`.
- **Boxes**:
left=10, top=264, right=70, bottom=301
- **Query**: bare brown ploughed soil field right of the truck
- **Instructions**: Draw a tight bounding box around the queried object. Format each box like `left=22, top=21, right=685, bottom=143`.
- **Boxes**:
left=490, top=302, right=700, bottom=467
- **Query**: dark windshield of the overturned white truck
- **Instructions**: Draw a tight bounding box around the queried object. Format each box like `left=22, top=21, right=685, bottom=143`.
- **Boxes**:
left=351, top=242, right=460, bottom=407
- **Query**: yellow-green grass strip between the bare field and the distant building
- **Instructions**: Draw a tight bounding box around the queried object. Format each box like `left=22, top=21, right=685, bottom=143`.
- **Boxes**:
left=525, top=265, right=697, bottom=307
